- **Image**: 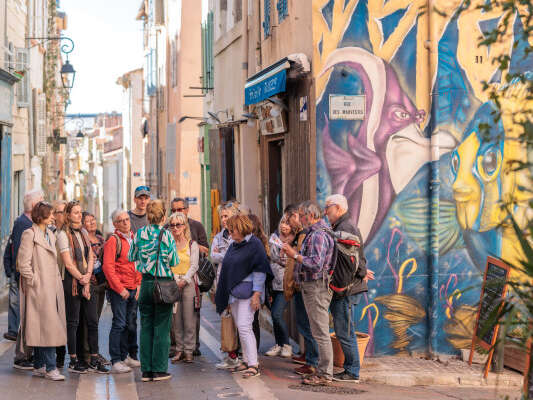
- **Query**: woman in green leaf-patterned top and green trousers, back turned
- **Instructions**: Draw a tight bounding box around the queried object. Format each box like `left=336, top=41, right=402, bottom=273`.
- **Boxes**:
left=128, top=200, right=179, bottom=382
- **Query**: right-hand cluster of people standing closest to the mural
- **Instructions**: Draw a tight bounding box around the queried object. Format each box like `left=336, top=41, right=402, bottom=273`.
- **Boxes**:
left=211, top=194, right=374, bottom=386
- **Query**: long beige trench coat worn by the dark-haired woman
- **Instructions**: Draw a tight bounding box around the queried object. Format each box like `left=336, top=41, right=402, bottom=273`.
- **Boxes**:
left=17, top=224, right=67, bottom=347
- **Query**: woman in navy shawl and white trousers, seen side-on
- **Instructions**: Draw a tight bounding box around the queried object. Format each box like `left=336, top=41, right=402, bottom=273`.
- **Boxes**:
left=215, top=215, right=272, bottom=378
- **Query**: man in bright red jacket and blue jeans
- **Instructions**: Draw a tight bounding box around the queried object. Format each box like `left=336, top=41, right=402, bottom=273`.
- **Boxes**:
left=103, top=210, right=141, bottom=374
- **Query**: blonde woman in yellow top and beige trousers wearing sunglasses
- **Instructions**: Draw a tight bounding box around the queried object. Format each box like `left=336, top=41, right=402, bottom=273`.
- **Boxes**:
left=168, top=212, right=200, bottom=363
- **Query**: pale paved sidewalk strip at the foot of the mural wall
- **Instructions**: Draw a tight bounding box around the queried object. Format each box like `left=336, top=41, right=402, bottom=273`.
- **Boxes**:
left=361, top=356, right=523, bottom=390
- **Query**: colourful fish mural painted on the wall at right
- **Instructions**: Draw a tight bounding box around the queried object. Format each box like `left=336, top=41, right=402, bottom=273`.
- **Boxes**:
left=313, top=0, right=533, bottom=354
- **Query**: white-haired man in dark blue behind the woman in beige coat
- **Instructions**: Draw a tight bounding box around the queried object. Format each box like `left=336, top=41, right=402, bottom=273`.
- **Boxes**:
left=4, top=189, right=44, bottom=369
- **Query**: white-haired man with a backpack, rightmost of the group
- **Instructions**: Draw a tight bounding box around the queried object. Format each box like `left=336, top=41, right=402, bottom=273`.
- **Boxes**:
left=325, top=194, right=374, bottom=382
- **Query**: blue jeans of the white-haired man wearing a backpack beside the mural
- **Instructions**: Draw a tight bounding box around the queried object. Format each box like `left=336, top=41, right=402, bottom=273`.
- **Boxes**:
left=329, top=293, right=361, bottom=378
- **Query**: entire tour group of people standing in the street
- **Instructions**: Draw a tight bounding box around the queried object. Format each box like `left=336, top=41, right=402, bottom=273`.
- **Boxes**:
left=4, top=186, right=373, bottom=385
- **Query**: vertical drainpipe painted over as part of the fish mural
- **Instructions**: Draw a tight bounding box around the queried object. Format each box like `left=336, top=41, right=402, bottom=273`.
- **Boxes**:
left=426, top=0, right=440, bottom=358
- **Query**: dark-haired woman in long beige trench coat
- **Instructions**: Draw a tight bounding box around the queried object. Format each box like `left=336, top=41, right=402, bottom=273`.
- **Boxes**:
left=17, top=201, right=67, bottom=381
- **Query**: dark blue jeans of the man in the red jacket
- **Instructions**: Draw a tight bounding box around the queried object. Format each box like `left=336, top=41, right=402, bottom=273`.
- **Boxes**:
left=109, top=289, right=137, bottom=364
